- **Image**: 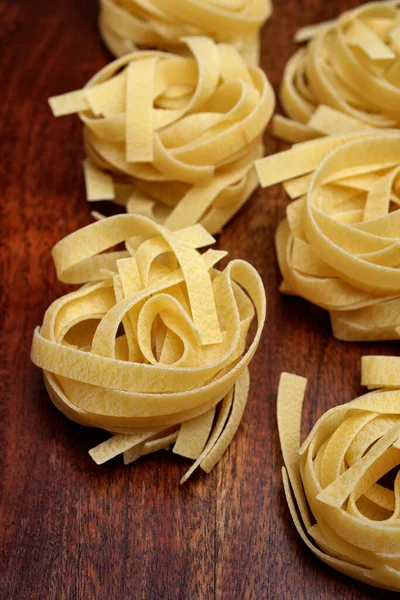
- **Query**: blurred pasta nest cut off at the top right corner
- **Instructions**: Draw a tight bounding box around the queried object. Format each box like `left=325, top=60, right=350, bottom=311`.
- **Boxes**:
left=273, top=0, right=400, bottom=142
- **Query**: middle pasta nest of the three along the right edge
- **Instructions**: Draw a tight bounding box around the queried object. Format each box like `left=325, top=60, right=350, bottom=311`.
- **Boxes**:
left=256, top=130, right=400, bottom=341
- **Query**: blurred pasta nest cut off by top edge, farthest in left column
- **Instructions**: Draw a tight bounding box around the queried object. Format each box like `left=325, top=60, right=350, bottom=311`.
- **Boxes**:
left=99, top=0, right=272, bottom=65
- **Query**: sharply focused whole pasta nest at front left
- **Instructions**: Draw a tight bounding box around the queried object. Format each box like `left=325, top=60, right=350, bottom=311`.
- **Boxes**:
left=32, top=215, right=266, bottom=480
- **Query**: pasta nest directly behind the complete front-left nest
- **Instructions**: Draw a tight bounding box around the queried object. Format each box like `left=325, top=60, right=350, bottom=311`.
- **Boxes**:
left=50, top=37, right=274, bottom=233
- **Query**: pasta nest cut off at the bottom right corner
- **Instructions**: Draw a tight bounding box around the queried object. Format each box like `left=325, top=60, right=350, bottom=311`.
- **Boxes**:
left=277, top=357, right=400, bottom=592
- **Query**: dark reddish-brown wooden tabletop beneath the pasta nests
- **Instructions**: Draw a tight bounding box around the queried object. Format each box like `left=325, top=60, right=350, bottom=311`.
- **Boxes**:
left=0, top=0, right=398, bottom=600
